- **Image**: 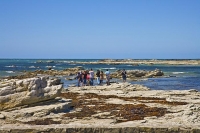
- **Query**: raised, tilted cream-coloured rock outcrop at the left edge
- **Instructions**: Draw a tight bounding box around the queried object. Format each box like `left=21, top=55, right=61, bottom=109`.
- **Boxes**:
left=0, top=77, right=63, bottom=111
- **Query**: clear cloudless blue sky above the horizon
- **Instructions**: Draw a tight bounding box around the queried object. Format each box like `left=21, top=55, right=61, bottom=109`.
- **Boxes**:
left=0, top=0, right=200, bottom=59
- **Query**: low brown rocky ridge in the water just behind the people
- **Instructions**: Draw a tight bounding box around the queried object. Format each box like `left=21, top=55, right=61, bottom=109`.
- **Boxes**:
left=4, top=66, right=164, bottom=80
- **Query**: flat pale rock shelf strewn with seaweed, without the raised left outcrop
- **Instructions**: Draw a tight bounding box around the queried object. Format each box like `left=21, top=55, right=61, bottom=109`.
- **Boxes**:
left=0, top=83, right=200, bottom=133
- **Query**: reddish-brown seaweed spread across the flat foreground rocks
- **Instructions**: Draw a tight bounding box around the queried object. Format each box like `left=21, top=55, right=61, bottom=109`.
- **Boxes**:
left=61, top=92, right=187, bottom=122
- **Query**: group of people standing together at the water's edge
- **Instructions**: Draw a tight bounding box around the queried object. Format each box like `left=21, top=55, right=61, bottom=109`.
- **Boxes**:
left=76, top=68, right=127, bottom=86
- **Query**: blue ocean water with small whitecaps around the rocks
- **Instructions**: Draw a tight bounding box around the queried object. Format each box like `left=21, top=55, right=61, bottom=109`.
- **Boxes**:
left=0, top=59, right=200, bottom=91
